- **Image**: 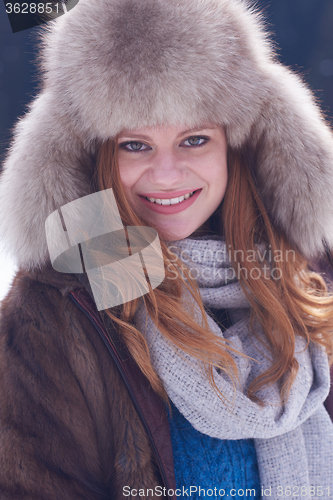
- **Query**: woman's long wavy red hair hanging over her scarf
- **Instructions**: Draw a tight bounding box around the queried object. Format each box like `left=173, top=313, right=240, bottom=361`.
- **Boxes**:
left=94, top=139, right=333, bottom=403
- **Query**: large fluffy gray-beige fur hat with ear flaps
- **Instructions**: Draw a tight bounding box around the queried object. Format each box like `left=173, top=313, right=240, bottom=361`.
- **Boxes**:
left=0, top=0, right=333, bottom=267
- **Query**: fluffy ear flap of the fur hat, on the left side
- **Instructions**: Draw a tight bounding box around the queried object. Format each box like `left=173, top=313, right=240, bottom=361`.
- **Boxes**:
left=0, top=91, right=93, bottom=268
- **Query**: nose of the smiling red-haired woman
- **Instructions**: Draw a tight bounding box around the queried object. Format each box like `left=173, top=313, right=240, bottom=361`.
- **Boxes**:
left=148, top=151, right=186, bottom=189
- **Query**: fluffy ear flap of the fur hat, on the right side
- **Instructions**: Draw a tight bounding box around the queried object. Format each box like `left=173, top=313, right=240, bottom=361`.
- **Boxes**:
left=250, top=64, right=333, bottom=258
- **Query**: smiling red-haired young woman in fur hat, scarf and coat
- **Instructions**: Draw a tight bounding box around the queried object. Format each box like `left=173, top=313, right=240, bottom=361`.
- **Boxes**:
left=0, top=0, right=333, bottom=500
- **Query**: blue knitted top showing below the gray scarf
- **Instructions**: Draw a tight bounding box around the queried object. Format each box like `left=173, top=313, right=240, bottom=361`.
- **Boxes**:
left=169, top=403, right=260, bottom=500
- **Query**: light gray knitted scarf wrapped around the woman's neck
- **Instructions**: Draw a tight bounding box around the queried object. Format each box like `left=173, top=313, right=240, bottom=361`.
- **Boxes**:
left=135, top=237, right=333, bottom=499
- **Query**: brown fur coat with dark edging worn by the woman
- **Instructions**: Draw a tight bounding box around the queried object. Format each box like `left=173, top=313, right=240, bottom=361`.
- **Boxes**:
left=0, top=267, right=174, bottom=500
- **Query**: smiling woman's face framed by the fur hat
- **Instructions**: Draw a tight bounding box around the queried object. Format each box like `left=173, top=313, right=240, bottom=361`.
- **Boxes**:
left=118, top=123, right=227, bottom=241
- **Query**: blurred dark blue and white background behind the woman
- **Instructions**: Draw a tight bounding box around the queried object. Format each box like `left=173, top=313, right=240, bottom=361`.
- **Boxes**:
left=0, top=0, right=333, bottom=300
